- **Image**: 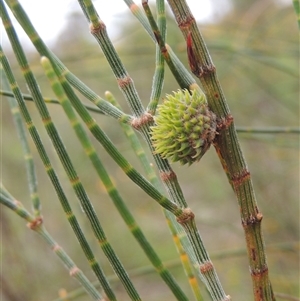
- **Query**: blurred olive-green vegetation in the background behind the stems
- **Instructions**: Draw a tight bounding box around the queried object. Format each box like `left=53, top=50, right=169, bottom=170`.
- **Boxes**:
left=0, top=0, right=299, bottom=301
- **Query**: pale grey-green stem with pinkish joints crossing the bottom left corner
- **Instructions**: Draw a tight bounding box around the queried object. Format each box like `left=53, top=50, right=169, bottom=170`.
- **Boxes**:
left=0, top=188, right=104, bottom=301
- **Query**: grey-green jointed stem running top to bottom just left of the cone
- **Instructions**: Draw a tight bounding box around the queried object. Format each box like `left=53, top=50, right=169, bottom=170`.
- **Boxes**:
left=77, top=0, right=228, bottom=300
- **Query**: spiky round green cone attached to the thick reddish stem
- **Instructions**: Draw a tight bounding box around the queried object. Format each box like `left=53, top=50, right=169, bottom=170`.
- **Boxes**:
left=151, top=90, right=217, bottom=165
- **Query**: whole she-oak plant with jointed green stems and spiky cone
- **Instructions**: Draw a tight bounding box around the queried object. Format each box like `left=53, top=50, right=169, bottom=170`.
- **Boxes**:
left=0, top=0, right=284, bottom=301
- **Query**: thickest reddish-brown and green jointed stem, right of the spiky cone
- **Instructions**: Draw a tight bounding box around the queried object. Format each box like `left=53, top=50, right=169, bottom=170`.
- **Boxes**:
left=168, top=0, right=275, bottom=300
